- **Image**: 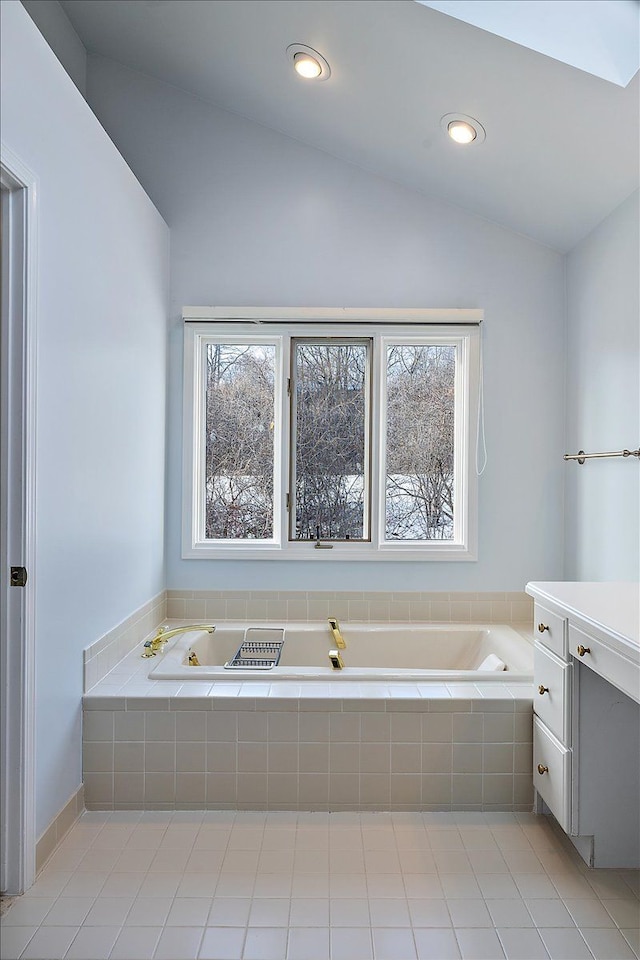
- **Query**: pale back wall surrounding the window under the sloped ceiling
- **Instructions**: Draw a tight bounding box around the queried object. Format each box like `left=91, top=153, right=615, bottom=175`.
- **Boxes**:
left=88, top=57, right=564, bottom=590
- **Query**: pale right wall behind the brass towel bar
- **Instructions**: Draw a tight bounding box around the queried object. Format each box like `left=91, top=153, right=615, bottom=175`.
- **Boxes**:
left=565, top=192, right=640, bottom=580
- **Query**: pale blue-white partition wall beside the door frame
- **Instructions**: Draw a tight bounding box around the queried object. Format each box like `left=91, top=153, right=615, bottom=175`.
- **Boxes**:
left=1, top=0, right=168, bottom=834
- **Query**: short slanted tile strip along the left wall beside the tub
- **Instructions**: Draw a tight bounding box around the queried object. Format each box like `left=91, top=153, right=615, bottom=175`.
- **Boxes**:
left=83, top=590, right=167, bottom=693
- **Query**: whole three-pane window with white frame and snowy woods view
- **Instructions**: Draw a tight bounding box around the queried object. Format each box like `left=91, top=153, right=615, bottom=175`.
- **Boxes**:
left=183, top=311, right=479, bottom=561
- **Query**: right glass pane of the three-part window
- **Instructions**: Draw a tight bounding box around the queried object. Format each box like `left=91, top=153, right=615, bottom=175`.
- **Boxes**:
left=385, top=345, right=456, bottom=540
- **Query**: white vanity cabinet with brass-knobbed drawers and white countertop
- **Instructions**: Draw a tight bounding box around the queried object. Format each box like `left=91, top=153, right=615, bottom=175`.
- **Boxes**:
left=527, top=583, right=640, bottom=867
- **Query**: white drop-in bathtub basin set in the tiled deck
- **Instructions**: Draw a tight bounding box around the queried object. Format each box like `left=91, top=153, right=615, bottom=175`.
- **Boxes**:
left=149, top=621, right=533, bottom=683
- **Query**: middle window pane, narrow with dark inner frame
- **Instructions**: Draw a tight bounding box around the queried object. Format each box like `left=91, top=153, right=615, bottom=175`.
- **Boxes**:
left=292, top=341, right=369, bottom=540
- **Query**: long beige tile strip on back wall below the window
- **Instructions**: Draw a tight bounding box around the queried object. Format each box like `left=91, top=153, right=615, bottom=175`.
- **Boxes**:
left=167, top=590, right=533, bottom=626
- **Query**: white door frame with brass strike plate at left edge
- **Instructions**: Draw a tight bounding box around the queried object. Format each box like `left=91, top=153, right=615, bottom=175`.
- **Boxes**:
left=0, top=143, right=38, bottom=894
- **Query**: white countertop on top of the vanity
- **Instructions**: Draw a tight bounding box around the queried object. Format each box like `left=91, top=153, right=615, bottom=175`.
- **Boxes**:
left=526, top=581, right=640, bottom=651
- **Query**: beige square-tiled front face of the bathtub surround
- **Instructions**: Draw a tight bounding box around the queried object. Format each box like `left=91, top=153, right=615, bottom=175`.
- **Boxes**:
left=83, top=684, right=533, bottom=810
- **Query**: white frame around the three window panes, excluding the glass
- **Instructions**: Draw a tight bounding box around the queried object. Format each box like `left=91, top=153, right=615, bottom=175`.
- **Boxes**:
left=182, top=307, right=482, bottom=563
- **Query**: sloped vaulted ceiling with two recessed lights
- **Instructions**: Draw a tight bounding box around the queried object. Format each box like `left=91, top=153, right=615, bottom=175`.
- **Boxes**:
left=61, top=0, right=640, bottom=250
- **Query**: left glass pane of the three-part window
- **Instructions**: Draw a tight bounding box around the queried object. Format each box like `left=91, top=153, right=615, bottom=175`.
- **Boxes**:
left=205, top=343, right=275, bottom=540
